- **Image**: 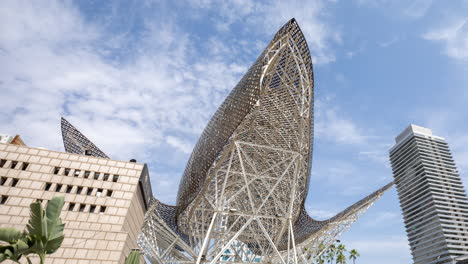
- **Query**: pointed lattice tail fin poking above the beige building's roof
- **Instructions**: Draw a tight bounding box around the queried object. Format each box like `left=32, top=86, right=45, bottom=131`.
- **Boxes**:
left=60, top=117, right=109, bottom=159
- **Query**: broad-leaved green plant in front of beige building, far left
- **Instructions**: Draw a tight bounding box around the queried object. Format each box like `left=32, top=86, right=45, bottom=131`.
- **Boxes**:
left=0, top=197, right=65, bottom=264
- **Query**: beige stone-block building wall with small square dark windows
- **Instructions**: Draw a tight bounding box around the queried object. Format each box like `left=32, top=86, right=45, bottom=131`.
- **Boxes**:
left=0, top=144, right=144, bottom=264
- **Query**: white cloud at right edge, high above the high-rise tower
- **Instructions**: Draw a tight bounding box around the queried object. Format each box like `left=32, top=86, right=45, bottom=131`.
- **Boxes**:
left=423, top=17, right=468, bottom=61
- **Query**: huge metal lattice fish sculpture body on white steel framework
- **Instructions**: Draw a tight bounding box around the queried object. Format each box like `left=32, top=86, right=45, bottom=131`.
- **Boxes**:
left=138, top=19, right=392, bottom=264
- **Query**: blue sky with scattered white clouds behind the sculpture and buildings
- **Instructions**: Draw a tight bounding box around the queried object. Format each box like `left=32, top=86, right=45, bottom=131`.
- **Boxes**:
left=0, top=0, right=468, bottom=264
